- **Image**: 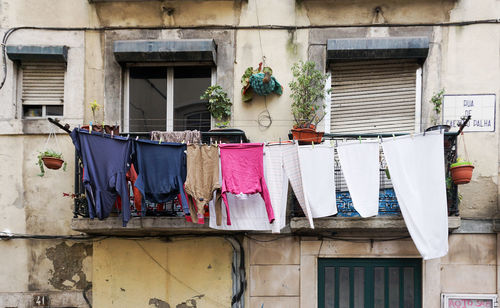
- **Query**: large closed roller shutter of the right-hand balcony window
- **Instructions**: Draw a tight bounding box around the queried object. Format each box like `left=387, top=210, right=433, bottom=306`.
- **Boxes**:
left=331, top=59, right=419, bottom=133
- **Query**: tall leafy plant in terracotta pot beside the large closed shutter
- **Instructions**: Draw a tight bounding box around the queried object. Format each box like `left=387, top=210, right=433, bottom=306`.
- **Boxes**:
left=288, top=61, right=331, bottom=144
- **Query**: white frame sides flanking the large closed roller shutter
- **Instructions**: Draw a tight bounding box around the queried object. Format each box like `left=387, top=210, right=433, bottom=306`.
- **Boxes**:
left=324, top=64, right=422, bottom=134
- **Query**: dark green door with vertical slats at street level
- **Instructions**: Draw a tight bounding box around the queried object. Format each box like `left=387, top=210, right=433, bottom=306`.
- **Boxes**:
left=318, top=259, right=422, bottom=308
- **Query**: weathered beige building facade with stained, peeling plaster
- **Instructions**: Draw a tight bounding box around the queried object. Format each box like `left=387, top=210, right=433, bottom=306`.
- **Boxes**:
left=0, top=0, right=500, bottom=308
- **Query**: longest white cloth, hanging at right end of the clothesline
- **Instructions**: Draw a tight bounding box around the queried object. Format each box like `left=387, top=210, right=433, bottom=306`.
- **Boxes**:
left=382, top=132, right=448, bottom=260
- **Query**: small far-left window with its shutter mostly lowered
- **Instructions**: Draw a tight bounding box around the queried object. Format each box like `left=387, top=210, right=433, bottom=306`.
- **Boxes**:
left=20, top=63, right=66, bottom=118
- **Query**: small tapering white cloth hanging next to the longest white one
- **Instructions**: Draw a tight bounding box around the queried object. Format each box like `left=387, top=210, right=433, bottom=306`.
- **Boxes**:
left=337, top=141, right=380, bottom=217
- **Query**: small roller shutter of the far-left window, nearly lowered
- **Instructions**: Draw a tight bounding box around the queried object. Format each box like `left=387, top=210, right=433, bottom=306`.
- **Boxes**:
left=21, top=63, right=66, bottom=105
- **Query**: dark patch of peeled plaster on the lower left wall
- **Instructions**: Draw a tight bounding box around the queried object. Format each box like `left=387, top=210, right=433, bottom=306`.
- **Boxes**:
left=45, top=242, right=92, bottom=290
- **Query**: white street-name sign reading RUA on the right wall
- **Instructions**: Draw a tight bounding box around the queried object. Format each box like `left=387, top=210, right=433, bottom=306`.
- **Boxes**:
left=442, top=94, right=495, bottom=132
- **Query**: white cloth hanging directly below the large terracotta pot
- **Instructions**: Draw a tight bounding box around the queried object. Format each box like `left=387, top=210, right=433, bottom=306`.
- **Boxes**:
left=299, top=144, right=337, bottom=218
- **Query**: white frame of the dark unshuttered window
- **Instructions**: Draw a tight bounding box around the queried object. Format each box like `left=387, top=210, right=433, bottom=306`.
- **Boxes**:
left=121, top=63, right=217, bottom=133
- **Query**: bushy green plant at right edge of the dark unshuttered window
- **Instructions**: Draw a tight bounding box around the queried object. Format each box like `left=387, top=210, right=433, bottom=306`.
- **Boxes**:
left=200, top=85, right=233, bottom=127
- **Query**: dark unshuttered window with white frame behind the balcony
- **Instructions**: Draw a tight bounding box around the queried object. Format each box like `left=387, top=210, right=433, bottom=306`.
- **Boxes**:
left=124, top=66, right=212, bottom=132
